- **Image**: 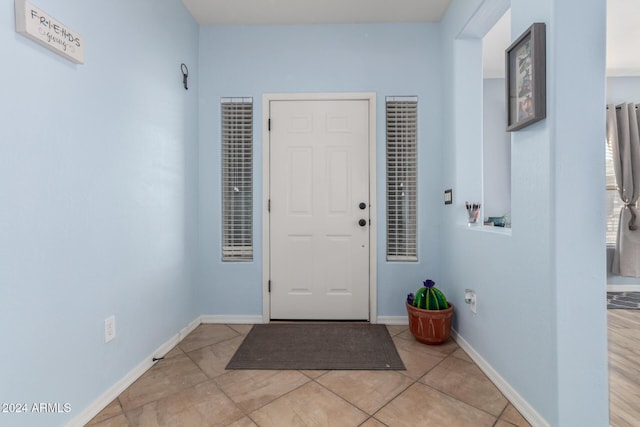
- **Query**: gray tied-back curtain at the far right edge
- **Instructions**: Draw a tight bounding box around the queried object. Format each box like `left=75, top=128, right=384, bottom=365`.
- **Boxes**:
left=607, top=103, right=640, bottom=277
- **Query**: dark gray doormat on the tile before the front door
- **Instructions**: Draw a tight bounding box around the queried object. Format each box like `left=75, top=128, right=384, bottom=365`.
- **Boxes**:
left=227, top=323, right=405, bottom=370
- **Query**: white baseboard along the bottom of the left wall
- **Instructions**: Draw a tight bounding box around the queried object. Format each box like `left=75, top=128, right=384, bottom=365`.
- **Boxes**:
left=66, top=317, right=201, bottom=427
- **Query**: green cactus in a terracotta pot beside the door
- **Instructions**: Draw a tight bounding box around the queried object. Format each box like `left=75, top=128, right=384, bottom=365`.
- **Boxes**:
left=406, top=279, right=453, bottom=345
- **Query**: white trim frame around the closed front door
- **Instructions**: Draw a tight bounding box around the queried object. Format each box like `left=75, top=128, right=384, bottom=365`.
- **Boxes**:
left=262, top=92, right=378, bottom=323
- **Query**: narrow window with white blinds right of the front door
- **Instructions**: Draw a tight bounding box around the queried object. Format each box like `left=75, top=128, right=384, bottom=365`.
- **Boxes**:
left=386, top=97, right=418, bottom=261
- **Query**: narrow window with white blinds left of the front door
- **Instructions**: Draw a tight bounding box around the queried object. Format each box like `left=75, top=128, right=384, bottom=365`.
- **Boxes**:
left=221, top=98, right=253, bottom=261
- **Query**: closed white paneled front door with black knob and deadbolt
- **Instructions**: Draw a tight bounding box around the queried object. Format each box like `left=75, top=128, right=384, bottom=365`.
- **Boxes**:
left=269, top=100, right=371, bottom=320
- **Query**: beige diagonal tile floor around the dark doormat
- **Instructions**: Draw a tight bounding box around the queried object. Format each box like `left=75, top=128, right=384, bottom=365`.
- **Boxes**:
left=88, top=325, right=529, bottom=427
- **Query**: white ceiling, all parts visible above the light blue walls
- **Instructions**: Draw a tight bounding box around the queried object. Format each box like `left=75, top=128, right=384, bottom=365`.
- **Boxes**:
left=182, top=0, right=640, bottom=77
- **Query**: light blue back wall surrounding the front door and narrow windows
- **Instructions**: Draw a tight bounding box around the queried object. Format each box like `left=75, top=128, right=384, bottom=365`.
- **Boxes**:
left=197, top=24, right=443, bottom=316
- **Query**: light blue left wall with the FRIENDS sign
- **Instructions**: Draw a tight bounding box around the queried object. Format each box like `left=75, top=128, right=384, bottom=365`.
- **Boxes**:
left=0, top=0, right=198, bottom=426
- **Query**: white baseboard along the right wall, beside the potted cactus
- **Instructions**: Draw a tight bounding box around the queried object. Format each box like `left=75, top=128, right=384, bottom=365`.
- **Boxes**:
left=451, top=330, right=550, bottom=427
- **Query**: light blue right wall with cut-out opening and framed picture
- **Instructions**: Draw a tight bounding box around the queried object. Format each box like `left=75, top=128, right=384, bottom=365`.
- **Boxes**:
left=442, top=0, right=608, bottom=426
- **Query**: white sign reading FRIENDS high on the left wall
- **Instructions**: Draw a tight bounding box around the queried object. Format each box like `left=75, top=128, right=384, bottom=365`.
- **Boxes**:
left=15, top=0, right=84, bottom=64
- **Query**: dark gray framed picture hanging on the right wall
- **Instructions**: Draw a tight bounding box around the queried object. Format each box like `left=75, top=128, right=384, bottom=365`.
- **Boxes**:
left=505, top=22, right=547, bottom=132
